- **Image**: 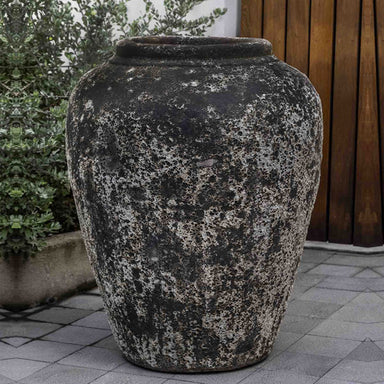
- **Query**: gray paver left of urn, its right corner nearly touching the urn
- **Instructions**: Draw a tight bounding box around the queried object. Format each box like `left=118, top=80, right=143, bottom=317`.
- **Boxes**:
left=44, top=325, right=111, bottom=345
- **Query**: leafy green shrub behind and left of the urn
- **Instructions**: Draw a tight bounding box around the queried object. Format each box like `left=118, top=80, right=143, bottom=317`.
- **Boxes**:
left=0, top=0, right=225, bottom=257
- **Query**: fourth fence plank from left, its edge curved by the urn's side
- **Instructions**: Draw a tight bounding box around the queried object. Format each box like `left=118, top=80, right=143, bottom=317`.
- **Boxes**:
left=308, top=0, right=335, bottom=241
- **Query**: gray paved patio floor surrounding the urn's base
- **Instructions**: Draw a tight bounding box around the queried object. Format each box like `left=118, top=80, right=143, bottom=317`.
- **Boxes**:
left=0, top=250, right=384, bottom=384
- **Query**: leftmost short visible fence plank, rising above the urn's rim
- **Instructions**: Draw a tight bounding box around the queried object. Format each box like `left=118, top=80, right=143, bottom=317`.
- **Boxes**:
left=240, top=0, right=263, bottom=37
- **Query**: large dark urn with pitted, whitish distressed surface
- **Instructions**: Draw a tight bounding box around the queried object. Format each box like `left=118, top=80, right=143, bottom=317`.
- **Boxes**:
left=67, top=37, right=322, bottom=372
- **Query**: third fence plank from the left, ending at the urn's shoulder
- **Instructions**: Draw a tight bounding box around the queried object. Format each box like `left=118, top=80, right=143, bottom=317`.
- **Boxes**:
left=285, top=0, right=311, bottom=74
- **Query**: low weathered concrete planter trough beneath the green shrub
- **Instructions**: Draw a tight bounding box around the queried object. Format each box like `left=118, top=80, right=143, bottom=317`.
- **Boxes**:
left=0, top=231, right=95, bottom=310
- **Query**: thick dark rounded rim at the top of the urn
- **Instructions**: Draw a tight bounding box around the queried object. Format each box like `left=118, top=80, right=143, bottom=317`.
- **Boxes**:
left=116, top=36, right=272, bottom=60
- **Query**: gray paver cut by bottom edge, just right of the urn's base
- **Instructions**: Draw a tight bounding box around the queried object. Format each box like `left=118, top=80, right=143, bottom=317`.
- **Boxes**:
left=240, top=370, right=319, bottom=384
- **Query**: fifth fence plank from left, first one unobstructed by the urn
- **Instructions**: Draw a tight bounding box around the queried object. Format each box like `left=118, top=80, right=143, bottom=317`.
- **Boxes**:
left=328, top=0, right=361, bottom=244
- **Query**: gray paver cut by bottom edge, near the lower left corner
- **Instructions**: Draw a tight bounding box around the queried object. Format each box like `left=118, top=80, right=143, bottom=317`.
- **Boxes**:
left=21, top=364, right=105, bottom=384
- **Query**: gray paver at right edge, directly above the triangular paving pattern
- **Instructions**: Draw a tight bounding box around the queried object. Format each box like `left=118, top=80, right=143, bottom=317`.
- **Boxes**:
left=309, top=320, right=384, bottom=341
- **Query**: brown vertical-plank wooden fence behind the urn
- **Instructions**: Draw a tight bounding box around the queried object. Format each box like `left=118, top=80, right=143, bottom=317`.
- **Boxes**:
left=241, top=0, right=384, bottom=247
